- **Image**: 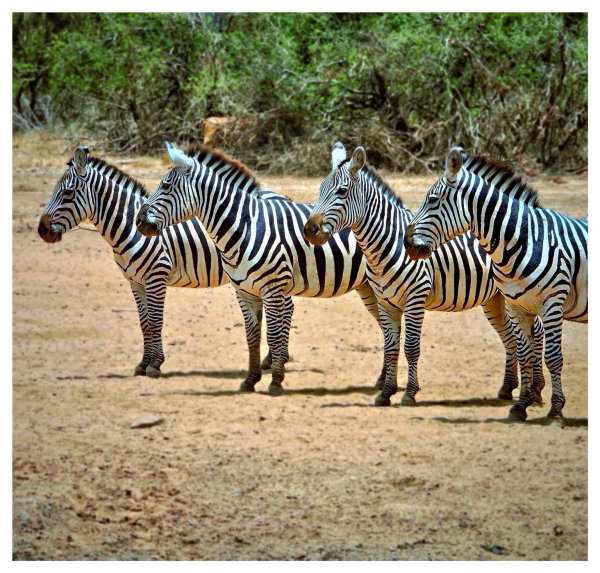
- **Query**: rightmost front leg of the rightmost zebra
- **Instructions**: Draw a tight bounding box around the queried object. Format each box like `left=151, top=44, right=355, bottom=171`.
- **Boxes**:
left=542, top=306, right=565, bottom=418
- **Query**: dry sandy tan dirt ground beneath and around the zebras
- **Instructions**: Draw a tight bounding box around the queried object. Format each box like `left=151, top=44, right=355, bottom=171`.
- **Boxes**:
left=12, top=136, right=588, bottom=560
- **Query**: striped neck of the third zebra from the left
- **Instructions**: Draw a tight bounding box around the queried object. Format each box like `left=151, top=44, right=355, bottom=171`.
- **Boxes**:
left=352, top=185, right=412, bottom=276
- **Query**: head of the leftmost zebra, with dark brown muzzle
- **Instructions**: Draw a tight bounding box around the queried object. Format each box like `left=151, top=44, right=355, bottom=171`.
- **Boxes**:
left=38, top=147, right=92, bottom=243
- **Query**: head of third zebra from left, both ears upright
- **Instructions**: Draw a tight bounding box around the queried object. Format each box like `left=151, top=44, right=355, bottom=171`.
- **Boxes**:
left=304, top=141, right=367, bottom=245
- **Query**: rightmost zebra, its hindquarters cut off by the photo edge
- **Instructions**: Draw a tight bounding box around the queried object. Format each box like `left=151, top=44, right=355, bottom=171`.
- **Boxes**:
left=404, top=147, right=588, bottom=420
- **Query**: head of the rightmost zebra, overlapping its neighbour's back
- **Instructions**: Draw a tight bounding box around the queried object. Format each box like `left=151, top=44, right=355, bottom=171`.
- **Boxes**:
left=404, top=147, right=469, bottom=261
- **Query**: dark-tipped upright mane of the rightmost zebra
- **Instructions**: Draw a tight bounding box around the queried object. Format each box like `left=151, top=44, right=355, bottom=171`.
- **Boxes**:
left=465, top=155, right=542, bottom=208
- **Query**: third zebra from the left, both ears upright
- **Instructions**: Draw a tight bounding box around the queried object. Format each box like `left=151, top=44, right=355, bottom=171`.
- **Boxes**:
left=304, top=142, right=544, bottom=406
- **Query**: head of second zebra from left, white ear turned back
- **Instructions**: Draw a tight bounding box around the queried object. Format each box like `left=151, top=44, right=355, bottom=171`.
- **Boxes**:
left=136, top=142, right=197, bottom=237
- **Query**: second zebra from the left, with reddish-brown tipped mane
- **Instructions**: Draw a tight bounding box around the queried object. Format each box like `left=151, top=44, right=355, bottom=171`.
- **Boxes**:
left=137, top=143, right=385, bottom=396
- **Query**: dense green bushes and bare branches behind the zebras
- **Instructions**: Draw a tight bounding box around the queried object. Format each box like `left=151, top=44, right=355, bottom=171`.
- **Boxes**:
left=13, top=14, right=588, bottom=174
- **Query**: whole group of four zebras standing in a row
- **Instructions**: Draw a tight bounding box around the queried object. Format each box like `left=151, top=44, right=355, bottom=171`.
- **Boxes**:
left=38, top=143, right=587, bottom=420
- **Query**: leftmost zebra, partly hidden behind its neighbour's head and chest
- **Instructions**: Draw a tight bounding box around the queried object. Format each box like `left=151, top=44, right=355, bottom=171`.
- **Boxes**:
left=38, top=147, right=326, bottom=378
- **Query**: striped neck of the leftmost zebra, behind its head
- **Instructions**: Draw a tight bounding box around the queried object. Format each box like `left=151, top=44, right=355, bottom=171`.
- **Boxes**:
left=90, top=174, right=146, bottom=254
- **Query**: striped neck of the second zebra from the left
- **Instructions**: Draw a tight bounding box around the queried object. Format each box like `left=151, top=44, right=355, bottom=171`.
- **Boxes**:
left=196, top=170, right=255, bottom=260
